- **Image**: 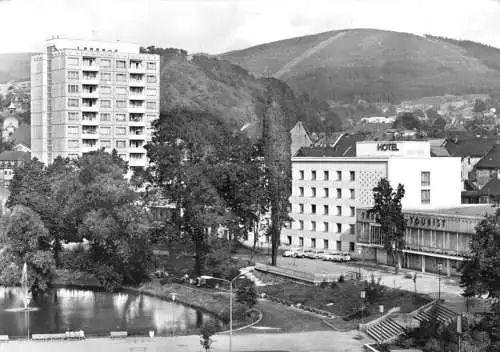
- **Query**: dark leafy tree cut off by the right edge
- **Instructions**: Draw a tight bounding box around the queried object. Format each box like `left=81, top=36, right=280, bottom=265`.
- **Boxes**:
left=460, top=210, right=500, bottom=298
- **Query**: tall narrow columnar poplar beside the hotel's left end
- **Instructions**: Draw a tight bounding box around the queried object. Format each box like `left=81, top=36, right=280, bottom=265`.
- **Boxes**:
left=263, top=95, right=292, bottom=265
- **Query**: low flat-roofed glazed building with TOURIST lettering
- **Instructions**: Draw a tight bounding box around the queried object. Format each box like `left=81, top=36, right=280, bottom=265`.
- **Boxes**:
left=356, top=205, right=496, bottom=276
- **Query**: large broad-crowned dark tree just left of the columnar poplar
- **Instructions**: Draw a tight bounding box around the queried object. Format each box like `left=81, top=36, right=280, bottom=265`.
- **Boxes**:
left=146, top=110, right=262, bottom=275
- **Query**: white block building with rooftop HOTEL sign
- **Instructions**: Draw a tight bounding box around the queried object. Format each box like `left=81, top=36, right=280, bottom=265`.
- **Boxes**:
left=281, top=141, right=461, bottom=252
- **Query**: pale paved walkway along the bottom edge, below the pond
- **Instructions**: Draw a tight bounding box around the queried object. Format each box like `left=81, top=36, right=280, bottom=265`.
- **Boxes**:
left=0, top=331, right=371, bottom=352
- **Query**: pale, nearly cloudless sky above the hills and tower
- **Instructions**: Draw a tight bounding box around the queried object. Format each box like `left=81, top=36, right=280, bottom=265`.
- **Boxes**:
left=0, top=0, right=500, bottom=54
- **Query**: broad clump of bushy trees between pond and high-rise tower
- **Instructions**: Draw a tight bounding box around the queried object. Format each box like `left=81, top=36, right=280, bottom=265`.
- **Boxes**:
left=7, top=150, right=152, bottom=290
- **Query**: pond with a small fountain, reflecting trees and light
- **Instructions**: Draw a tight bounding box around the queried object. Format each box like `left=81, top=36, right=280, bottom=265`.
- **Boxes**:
left=0, top=286, right=223, bottom=337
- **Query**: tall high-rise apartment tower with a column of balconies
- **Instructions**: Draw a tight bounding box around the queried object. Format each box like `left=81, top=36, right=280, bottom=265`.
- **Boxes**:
left=31, top=38, right=160, bottom=168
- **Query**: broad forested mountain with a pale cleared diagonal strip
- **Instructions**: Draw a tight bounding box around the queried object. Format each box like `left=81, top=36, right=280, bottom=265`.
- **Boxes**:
left=219, top=29, right=500, bottom=103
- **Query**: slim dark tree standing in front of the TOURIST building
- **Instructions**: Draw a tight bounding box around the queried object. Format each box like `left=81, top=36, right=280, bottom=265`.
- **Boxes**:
left=368, top=178, right=406, bottom=270
